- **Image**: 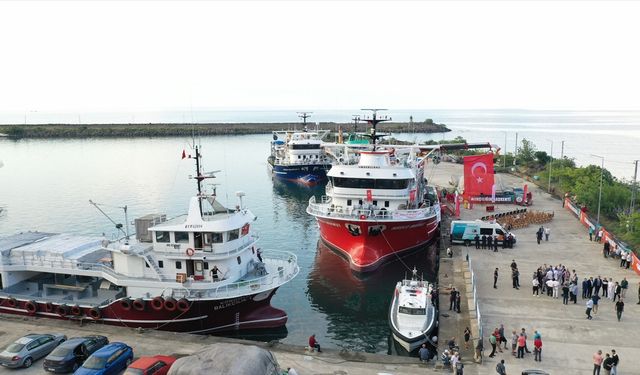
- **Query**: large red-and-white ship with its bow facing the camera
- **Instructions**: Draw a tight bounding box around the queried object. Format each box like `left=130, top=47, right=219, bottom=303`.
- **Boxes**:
left=307, top=110, right=440, bottom=272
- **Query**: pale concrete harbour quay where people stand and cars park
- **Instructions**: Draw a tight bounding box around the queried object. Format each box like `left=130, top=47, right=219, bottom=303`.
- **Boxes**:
left=0, top=162, right=640, bottom=375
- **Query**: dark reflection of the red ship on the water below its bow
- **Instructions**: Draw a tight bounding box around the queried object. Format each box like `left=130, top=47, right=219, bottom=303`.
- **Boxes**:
left=307, top=241, right=436, bottom=353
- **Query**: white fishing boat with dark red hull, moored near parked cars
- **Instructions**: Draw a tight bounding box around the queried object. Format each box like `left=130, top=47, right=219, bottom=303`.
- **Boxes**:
left=0, top=147, right=299, bottom=333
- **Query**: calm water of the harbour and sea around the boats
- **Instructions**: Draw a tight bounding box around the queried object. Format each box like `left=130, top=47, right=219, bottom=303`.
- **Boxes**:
left=0, top=111, right=640, bottom=353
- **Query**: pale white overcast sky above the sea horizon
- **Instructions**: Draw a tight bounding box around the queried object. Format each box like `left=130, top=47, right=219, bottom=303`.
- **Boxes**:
left=0, top=1, right=640, bottom=116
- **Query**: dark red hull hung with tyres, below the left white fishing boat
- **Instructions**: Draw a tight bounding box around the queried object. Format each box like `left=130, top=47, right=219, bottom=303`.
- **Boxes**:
left=0, top=289, right=287, bottom=334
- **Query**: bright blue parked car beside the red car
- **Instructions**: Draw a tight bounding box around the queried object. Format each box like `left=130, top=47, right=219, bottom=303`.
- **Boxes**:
left=73, top=342, right=133, bottom=375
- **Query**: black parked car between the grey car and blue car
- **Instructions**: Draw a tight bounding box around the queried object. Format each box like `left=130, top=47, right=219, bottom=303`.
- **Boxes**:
left=42, top=335, right=109, bottom=373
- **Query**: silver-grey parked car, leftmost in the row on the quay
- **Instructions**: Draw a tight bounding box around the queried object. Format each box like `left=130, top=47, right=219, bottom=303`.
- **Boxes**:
left=0, top=333, right=67, bottom=368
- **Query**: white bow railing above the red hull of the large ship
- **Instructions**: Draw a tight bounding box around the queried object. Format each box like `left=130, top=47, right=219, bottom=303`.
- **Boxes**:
left=307, top=196, right=437, bottom=220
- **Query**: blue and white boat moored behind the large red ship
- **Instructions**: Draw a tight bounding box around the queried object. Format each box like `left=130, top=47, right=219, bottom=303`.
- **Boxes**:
left=267, top=113, right=331, bottom=186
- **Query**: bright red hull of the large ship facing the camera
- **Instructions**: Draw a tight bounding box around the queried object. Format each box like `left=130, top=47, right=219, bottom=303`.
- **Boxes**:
left=317, top=216, right=438, bottom=272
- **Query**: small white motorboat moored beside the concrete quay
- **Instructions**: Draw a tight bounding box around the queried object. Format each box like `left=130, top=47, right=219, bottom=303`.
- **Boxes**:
left=389, top=268, right=438, bottom=352
